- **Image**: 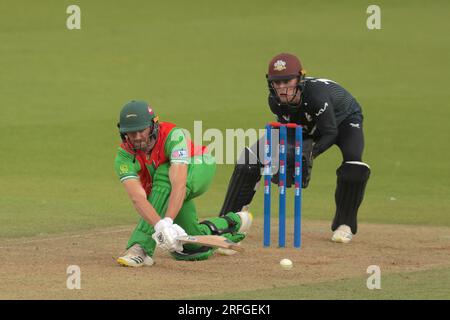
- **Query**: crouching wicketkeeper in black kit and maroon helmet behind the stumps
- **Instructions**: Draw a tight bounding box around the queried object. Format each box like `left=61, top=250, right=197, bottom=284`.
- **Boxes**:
left=221, top=53, right=370, bottom=243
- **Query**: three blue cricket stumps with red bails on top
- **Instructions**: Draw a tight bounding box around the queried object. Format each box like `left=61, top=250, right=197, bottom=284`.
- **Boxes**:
left=264, top=122, right=303, bottom=248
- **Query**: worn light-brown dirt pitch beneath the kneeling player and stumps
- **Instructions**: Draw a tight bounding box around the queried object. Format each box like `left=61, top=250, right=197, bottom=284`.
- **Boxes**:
left=0, top=220, right=450, bottom=299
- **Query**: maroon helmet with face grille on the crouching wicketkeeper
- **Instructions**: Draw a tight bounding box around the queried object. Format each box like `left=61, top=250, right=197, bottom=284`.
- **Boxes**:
left=266, top=53, right=306, bottom=106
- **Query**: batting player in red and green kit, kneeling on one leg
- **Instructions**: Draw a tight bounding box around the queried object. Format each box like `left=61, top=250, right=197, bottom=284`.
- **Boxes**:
left=115, top=100, right=252, bottom=267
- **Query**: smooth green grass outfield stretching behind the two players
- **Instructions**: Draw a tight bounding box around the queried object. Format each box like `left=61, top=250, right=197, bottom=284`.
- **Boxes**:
left=0, top=0, right=450, bottom=299
